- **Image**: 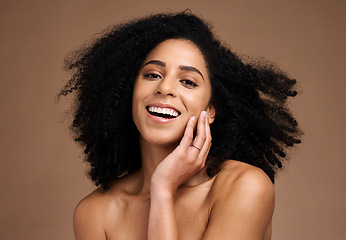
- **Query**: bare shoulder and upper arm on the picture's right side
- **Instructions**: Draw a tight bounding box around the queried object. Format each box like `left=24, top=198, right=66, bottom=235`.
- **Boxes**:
left=203, top=160, right=275, bottom=240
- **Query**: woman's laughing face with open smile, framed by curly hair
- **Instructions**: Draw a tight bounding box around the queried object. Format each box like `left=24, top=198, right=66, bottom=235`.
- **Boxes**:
left=132, top=39, right=213, bottom=145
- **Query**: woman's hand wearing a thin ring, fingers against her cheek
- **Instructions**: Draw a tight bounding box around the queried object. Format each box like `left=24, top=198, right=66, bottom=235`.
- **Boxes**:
left=151, top=111, right=211, bottom=194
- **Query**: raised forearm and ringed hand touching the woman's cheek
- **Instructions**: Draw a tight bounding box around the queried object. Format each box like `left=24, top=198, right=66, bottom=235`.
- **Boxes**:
left=148, top=112, right=211, bottom=240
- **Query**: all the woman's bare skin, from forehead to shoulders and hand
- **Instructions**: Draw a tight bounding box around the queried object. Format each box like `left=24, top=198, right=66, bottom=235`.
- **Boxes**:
left=74, top=40, right=274, bottom=240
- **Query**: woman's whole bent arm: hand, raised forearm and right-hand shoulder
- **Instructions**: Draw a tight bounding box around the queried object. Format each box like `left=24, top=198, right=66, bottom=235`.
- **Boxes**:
left=148, top=111, right=275, bottom=240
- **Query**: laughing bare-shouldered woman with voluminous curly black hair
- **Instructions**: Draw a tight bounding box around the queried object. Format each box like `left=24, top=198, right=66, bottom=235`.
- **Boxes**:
left=60, top=12, right=300, bottom=240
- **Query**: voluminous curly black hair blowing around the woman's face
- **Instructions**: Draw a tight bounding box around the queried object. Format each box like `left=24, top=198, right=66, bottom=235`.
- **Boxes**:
left=59, top=11, right=301, bottom=189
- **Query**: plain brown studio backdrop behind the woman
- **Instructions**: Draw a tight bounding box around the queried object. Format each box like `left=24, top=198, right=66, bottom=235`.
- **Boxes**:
left=0, top=0, right=346, bottom=240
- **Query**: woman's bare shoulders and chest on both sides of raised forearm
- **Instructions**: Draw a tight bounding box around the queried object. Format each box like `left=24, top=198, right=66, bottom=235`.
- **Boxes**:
left=74, top=161, right=274, bottom=240
